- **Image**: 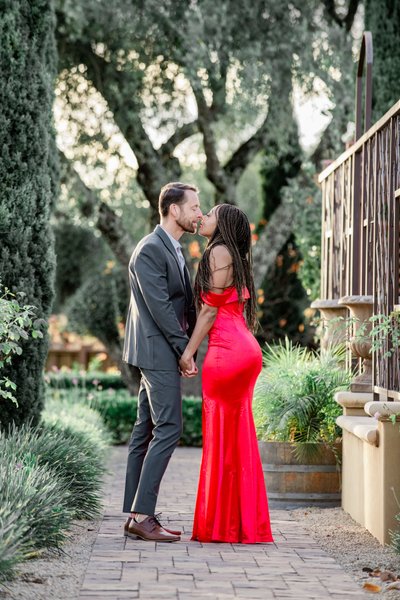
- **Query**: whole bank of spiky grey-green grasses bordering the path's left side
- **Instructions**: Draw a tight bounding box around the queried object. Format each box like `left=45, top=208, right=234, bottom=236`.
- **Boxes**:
left=0, top=400, right=108, bottom=581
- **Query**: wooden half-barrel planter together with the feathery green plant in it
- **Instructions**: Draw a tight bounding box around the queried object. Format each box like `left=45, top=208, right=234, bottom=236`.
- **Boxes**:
left=253, top=339, right=351, bottom=507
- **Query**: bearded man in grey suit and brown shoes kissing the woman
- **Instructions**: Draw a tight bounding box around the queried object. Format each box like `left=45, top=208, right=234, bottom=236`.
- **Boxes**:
left=123, top=182, right=202, bottom=542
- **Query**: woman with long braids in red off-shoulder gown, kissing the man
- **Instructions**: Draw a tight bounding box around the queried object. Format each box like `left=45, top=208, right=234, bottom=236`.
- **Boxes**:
left=180, top=204, right=273, bottom=544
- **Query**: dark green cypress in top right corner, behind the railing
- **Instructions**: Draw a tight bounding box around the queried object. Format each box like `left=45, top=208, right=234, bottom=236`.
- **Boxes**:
left=365, top=0, right=400, bottom=121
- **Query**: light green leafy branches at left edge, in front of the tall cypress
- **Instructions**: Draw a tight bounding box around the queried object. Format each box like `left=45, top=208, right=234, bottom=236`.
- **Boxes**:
left=0, top=283, right=43, bottom=406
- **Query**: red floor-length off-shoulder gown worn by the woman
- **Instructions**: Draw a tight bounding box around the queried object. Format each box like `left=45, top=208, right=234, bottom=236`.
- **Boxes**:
left=192, top=287, right=273, bottom=544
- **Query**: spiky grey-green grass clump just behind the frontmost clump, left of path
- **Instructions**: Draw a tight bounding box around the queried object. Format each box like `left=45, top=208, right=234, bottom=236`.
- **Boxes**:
left=0, top=423, right=105, bottom=519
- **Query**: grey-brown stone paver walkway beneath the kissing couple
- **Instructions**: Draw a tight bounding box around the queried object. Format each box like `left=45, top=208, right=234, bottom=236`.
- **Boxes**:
left=80, top=447, right=368, bottom=600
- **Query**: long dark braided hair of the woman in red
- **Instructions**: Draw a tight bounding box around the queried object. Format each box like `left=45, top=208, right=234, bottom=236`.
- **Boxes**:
left=194, top=204, right=257, bottom=331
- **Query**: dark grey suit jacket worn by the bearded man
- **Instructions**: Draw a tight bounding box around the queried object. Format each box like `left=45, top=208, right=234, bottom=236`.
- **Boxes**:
left=123, top=225, right=196, bottom=370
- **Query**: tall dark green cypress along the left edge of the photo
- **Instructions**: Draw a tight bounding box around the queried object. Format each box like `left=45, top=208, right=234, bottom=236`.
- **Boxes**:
left=0, top=0, right=57, bottom=428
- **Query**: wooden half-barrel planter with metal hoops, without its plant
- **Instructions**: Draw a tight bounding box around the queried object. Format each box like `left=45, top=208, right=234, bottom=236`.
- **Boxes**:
left=258, top=441, right=341, bottom=508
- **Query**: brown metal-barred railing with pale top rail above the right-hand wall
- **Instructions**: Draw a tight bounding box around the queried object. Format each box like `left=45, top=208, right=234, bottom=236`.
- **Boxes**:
left=319, top=32, right=400, bottom=399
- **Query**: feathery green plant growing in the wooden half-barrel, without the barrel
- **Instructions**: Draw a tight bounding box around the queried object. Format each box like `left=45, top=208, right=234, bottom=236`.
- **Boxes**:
left=253, top=340, right=350, bottom=452
